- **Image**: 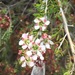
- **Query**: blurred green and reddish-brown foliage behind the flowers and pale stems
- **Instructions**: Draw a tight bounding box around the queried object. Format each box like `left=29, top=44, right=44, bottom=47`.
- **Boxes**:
left=0, top=0, right=75, bottom=75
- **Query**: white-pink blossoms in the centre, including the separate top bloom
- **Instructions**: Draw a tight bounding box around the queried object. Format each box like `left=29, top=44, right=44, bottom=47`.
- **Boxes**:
left=19, top=17, right=54, bottom=67
